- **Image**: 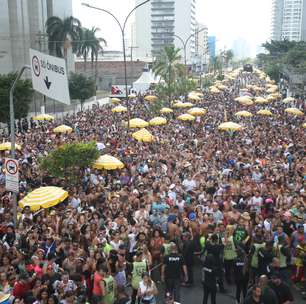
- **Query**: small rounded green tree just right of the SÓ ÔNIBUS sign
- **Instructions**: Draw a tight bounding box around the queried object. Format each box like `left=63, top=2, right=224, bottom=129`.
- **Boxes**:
left=69, top=73, right=96, bottom=109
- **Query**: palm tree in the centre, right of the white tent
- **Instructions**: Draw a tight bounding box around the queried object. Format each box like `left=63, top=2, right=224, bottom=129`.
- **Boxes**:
left=153, top=45, right=184, bottom=103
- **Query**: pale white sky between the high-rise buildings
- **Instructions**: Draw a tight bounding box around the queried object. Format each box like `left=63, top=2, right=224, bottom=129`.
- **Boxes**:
left=73, top=0, right=272, bottom=55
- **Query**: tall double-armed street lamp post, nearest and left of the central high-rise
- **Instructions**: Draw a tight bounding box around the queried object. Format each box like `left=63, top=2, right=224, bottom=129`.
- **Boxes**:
left=82, top=0, right=150, bottom=128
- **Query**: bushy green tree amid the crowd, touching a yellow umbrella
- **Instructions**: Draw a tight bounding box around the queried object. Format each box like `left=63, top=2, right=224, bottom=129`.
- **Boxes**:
left=40, top=142, right=99, bottom=183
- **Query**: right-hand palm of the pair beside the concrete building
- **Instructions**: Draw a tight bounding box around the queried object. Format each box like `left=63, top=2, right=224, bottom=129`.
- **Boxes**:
left=77, top=27, right=106, bottom=77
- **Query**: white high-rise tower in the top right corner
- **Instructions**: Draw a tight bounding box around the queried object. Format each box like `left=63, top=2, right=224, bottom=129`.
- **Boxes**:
left=271, top=0, right=306, bottom=41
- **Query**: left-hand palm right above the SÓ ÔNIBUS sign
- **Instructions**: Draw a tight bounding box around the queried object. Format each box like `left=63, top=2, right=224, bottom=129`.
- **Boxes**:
left=46, top=16, right=81, bottom=61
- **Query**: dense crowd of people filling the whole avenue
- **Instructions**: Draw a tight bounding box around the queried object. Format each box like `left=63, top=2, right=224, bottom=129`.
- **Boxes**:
left=0, top=72, right=306, bottom=304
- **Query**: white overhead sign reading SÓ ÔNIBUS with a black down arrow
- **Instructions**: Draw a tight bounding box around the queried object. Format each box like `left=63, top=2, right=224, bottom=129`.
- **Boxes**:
left=30, top=49, right=70, bottom=104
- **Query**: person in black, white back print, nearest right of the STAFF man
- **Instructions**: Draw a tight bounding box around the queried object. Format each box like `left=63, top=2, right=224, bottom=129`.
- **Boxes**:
left=202, top=254, right=217, bottom=304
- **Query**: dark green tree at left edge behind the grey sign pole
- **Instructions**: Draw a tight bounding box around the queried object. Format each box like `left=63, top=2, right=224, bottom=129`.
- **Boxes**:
left=0, top=73, right=34, bottom=123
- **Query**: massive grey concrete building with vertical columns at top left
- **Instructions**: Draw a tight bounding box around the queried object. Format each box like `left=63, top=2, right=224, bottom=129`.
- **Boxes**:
left=0, top=0, right=73, bottom=73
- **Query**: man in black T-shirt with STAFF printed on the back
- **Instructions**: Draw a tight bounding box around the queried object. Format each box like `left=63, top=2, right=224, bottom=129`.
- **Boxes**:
left=161, top=243, right=188, bottom=302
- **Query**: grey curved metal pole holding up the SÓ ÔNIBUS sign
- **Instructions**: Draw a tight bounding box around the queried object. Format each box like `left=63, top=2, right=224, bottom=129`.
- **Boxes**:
left=10, top=65, right=30, bottom=227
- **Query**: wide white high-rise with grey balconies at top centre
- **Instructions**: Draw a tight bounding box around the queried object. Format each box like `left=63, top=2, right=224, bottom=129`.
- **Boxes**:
left=135, top=0, right=196, bottom=63
